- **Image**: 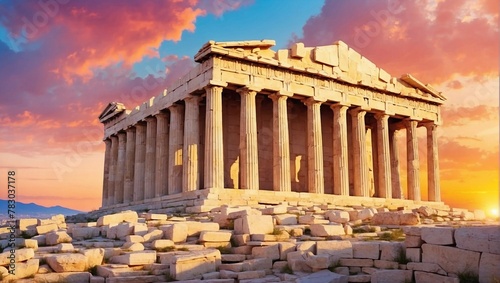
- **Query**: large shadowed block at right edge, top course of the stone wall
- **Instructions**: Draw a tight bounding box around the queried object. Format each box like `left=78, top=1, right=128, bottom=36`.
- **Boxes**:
left=455, top=226, right=500, bottom=254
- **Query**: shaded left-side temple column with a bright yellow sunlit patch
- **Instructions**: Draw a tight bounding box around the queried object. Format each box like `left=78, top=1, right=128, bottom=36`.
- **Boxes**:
left=168, top=104, right=184, bottom=195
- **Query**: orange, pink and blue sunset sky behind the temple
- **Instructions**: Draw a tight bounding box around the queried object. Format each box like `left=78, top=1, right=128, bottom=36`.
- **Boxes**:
left=0, top=0, right=499, bottom=213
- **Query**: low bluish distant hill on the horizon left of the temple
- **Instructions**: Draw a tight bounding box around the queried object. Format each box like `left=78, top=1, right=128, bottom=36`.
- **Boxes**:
left=0, top=199, right=82, bottom=219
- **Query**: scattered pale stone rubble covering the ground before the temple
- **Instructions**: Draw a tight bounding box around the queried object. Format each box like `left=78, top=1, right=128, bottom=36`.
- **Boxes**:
left=0, top=205, right=500, bottom=283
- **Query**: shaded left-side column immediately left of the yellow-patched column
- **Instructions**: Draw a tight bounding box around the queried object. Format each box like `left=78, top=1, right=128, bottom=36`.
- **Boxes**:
left=155, top=112, right=168, bottom=197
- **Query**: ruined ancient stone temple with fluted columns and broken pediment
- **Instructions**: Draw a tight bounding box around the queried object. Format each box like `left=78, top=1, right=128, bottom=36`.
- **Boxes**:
left=99, top=40, right=445, bottom=212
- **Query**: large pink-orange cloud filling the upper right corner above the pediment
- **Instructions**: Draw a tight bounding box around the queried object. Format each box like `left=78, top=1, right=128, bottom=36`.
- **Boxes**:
left=298, top=0, right=499, bottom=83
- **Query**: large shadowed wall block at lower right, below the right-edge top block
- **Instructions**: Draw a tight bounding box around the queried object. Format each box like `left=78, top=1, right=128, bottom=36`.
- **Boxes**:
left=422, top=244, right=480, bottom=274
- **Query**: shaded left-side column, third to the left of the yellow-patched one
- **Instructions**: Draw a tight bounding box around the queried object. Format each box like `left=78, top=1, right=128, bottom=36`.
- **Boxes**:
left=134, top=122, right=146, bottom=201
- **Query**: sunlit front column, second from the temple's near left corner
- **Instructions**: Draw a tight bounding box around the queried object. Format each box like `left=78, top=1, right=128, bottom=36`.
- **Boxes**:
left=238, top=88, right=259, bottom=190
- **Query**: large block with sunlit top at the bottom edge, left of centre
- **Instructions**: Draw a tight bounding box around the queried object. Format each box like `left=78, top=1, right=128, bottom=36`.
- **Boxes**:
left=170, top=250, right=221, bottom=280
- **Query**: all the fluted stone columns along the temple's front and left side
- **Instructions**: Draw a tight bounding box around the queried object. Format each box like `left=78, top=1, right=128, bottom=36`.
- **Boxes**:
left=103, top=86, right=440, bottom=205
